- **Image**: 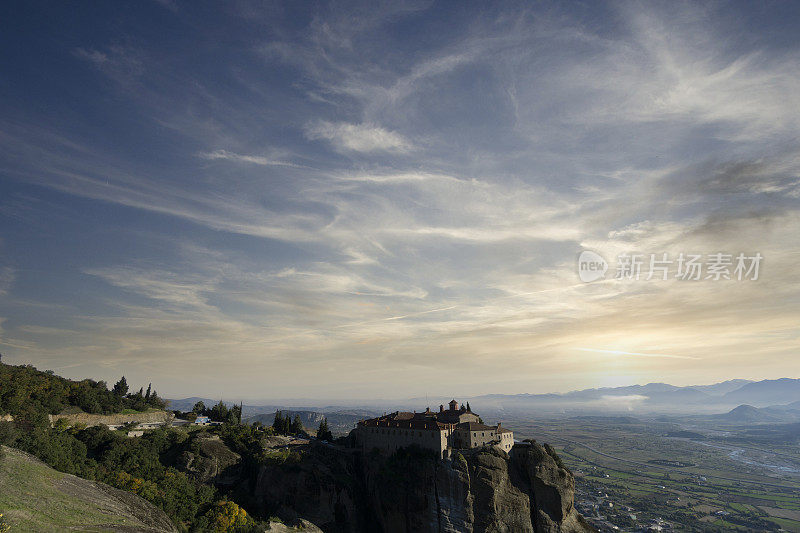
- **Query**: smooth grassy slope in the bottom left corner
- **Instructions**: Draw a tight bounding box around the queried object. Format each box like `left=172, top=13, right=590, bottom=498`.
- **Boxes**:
left=0, top=446, right=176, bottom=533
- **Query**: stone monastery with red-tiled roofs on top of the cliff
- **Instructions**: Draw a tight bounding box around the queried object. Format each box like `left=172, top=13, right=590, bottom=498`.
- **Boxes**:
left=351, top=400, right=514, bottom=458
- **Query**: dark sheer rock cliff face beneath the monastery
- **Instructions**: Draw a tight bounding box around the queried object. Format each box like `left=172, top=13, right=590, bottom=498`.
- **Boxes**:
left=244, top=444, right=593, bottom=533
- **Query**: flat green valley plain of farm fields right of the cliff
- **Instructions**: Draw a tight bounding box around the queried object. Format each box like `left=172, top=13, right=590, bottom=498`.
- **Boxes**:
left=507, top=416, right=800, bottom=531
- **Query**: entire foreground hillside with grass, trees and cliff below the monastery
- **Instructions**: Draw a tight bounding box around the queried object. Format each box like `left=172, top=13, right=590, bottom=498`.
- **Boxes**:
left=0, top=365, right=591, bottom=533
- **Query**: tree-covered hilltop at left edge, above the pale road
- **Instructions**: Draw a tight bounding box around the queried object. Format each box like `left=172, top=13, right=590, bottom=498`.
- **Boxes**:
left=0, top=363, right=166, bottom=417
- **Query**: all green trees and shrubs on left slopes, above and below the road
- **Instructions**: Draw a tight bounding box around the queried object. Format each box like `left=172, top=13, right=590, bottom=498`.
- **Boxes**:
left=0, top=363, right=264, bottom=532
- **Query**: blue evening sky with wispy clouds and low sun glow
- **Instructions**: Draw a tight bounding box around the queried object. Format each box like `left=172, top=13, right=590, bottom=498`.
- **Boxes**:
left=0, top=0, right=800, bottom=400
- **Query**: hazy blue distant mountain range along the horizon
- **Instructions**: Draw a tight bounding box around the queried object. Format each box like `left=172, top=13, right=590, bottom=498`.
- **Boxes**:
left=164, top=378, right=800, bottom=418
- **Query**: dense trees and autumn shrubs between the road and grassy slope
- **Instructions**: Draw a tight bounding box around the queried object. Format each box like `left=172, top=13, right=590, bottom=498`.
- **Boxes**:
left=0, top=408, right=276, bottom=532
